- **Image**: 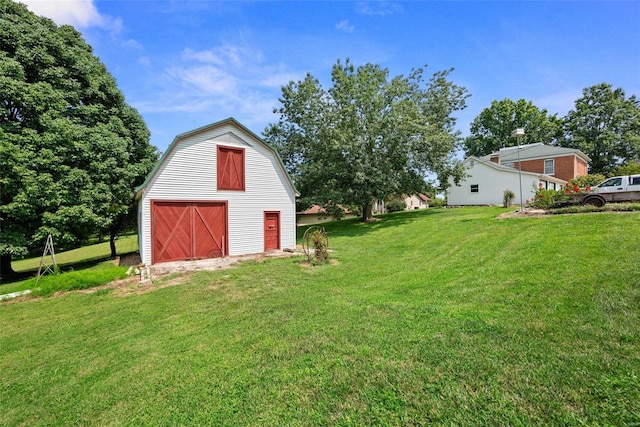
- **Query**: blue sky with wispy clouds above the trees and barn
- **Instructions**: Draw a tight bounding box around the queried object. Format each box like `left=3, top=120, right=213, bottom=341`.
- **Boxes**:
left=22, top=0, right=640, bottom=151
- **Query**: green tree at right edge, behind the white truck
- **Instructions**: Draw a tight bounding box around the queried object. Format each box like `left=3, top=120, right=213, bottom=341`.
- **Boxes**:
left=562, top=83, right=640, bottom=175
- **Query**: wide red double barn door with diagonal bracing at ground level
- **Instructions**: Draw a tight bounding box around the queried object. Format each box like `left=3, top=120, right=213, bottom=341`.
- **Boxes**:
left=151, top=202, right=228, bottom=263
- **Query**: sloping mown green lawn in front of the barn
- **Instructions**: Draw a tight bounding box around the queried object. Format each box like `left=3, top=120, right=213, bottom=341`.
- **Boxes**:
left=0, top=208, right=640, bottom=426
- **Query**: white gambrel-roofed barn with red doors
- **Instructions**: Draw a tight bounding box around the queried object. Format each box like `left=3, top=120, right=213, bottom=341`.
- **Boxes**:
left=136, top=118, right=297, bottom=264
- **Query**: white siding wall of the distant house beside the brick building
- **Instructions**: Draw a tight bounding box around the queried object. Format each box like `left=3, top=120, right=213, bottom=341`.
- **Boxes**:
left=447, top=160, right=539, bottom=206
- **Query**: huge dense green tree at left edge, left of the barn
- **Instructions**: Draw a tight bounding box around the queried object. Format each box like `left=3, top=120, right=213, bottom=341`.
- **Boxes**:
left=0, top=0, right=157, bottom=275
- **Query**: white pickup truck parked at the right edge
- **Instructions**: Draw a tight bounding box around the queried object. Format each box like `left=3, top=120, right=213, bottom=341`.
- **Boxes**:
left=584, top=175, right=640, bottom=206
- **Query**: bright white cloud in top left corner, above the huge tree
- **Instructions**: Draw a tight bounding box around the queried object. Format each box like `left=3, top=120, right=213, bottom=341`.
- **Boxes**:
left=20, top=0, right=122, bottom=32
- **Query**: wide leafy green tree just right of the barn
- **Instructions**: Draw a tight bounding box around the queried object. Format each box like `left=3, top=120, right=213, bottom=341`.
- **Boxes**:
left=264, top=59, right=468, bottom=220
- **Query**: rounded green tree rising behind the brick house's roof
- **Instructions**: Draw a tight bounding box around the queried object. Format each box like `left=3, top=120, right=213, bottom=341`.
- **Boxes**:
left=464, top=99, right=562, bottom=156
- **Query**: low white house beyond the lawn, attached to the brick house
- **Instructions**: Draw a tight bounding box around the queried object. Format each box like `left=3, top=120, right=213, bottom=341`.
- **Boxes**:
left=447, top=156, right=566, bottom=206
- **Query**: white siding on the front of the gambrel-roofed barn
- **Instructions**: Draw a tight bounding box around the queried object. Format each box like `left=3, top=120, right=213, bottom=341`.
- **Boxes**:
left=139, top=124, right=296, bottom=264
